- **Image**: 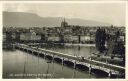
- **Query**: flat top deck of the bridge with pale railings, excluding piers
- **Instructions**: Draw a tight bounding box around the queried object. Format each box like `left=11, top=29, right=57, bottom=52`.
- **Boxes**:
left=16, top=44, right=125, bottom=72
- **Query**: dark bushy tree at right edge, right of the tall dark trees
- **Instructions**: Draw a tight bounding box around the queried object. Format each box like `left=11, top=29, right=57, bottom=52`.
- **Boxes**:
left=107, top=31, right=125, bottom=61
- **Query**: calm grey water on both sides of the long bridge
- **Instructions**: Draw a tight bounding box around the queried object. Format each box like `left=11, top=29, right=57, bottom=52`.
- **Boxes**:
left=3, top=46, right=99, bottom=78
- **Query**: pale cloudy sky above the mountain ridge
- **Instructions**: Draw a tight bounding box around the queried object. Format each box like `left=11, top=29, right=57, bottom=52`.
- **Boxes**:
left=3, top=3, right=126, bottom=26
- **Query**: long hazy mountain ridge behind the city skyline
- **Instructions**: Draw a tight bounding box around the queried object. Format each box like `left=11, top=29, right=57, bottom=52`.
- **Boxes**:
left=3, top=11, right=110, bottom=27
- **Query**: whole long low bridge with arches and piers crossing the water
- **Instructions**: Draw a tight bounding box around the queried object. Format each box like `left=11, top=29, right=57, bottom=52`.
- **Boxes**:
left=14, top=43, right=125, bottom=77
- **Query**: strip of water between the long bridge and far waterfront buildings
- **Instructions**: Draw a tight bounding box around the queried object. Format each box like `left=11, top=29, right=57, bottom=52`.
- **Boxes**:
left=39, top=45, right=96, bottom=57
